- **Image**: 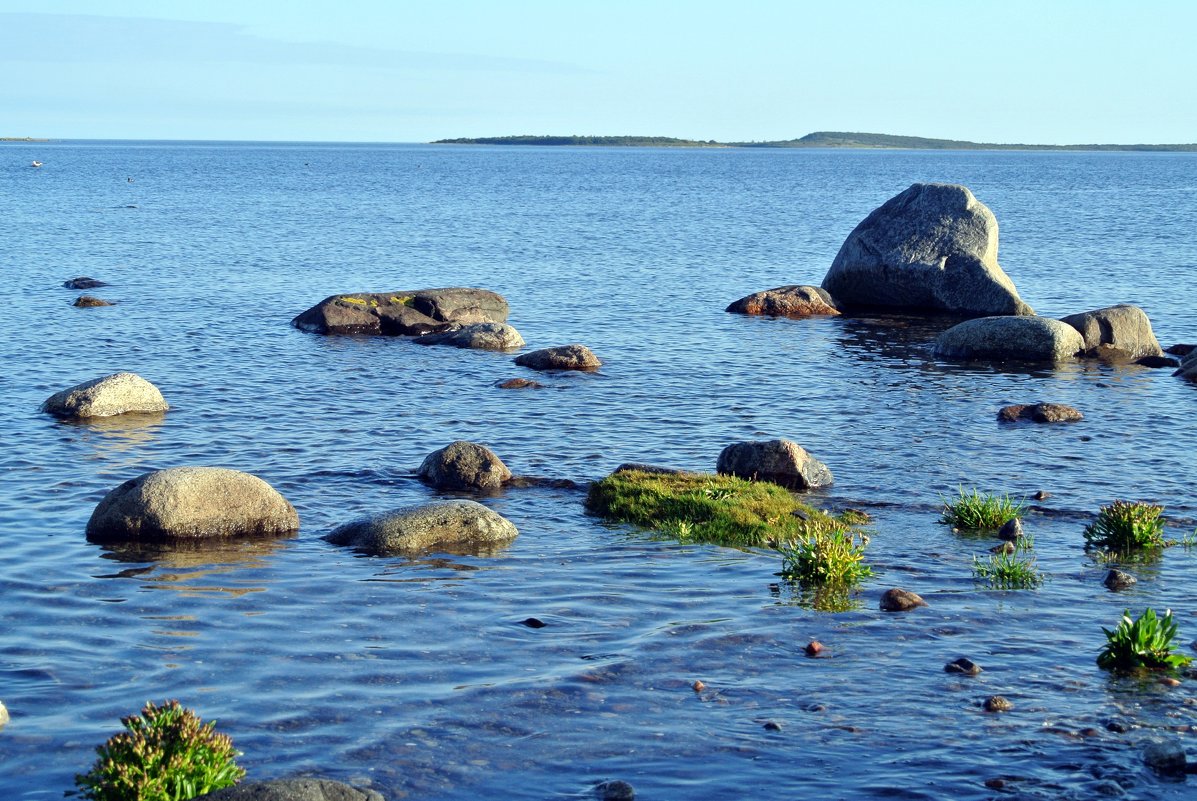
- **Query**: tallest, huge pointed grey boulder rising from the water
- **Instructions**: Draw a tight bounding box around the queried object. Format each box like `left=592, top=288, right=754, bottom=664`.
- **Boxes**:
left=822, top=183, right=1034, bottom=317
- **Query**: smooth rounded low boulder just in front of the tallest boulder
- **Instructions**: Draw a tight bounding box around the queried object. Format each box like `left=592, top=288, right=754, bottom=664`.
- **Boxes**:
left=935, top=317, right=1084, bottom=362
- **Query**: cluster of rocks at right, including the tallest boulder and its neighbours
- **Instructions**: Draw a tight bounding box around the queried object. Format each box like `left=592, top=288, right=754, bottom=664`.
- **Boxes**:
left=727, top=183, right=1182, bottom=368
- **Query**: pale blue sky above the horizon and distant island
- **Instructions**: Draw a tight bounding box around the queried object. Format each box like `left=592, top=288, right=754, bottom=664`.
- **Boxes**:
left=0, top=0, right=1197, bottom=144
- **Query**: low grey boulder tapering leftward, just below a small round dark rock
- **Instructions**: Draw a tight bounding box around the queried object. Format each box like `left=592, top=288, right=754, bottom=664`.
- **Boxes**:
left=324, top=500, right=519, bottom=556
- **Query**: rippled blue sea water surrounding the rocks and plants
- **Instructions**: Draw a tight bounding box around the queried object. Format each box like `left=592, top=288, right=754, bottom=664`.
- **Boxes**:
left=0, top=142, right=1197, bottom=800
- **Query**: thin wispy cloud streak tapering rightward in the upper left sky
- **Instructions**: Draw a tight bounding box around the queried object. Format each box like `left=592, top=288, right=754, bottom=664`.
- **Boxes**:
left=0, top=13, right=590, bottom=74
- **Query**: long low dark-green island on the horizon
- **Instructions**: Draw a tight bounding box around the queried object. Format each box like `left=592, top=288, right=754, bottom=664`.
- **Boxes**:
left=432, top=131, right=1197, bottom=153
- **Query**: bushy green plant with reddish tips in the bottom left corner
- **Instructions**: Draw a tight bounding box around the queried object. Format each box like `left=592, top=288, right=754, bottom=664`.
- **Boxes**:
left=75, top=700, right=245, bottom=801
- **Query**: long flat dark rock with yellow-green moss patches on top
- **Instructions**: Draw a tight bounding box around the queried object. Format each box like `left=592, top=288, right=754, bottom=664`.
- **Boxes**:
left=291, top=287, right=508, bottom=336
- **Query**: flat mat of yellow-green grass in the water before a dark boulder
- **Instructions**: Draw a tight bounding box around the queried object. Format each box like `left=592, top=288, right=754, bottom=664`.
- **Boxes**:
left=587, top=469, right=845, bottom=547
